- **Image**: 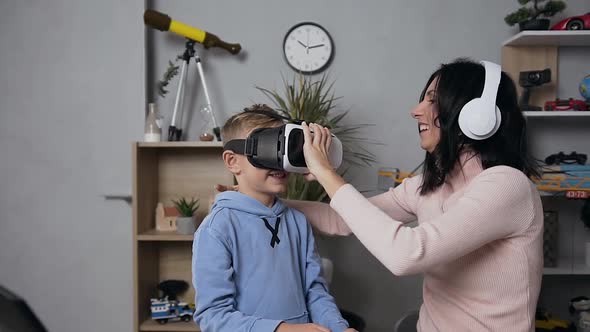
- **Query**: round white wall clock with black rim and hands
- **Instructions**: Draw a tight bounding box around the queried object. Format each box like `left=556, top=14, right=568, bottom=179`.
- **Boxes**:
left=283, top=22, right=334, bottom=74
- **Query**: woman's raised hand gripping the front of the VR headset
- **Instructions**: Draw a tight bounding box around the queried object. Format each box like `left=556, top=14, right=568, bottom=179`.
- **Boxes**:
left=301, top=122, right=346, bottom=197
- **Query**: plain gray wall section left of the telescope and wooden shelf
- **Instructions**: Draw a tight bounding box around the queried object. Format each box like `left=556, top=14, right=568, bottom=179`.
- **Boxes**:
left=0, top=0, right=145, bottom=332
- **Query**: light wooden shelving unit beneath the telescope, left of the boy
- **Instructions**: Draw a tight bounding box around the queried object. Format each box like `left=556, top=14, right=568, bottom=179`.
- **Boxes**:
left=132, top=142, right=232, bottom=332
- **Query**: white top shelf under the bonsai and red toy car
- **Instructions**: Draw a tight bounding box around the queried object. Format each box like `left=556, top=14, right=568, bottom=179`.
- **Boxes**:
left=502, top=30, right=590, bottom=46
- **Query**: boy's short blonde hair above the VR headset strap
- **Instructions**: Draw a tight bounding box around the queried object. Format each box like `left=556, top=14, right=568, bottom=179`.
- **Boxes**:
left=221, top=104, right=284, bottom=144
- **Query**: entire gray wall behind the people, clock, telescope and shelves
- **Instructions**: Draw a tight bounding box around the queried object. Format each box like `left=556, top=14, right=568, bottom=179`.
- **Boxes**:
left=0, top=0, right=590, bottom=332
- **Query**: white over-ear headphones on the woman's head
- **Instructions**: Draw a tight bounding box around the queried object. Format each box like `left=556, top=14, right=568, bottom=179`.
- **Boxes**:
left=459, top=61, right=502, bottom=141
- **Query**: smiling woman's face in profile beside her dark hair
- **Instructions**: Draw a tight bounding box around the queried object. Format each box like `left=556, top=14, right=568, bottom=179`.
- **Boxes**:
left=410, top=78, right=440, bottom=153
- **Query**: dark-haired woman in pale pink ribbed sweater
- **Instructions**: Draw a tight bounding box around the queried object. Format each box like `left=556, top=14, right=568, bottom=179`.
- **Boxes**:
left=290, top=60, right=543, bottom=331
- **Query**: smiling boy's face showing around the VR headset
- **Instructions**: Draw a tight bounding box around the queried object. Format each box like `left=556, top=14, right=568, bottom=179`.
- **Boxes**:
left=223, top=127, right=288, bottom=204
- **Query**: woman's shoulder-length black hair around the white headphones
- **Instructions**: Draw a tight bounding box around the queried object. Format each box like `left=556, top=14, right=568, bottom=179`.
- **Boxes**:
left=420, top=59, right=539, bottom=195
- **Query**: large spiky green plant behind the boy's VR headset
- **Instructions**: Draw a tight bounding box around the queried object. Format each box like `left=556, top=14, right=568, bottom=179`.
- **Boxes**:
left=256, top=74, right=379, bottom=201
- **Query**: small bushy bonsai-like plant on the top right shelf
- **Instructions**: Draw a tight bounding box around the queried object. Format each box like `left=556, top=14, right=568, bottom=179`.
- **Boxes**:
left=504, top=0, right=565, bottom=31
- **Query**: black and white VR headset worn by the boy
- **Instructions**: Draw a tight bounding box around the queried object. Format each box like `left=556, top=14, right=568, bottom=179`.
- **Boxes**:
left=223, top=123, right=342, bottom=173
